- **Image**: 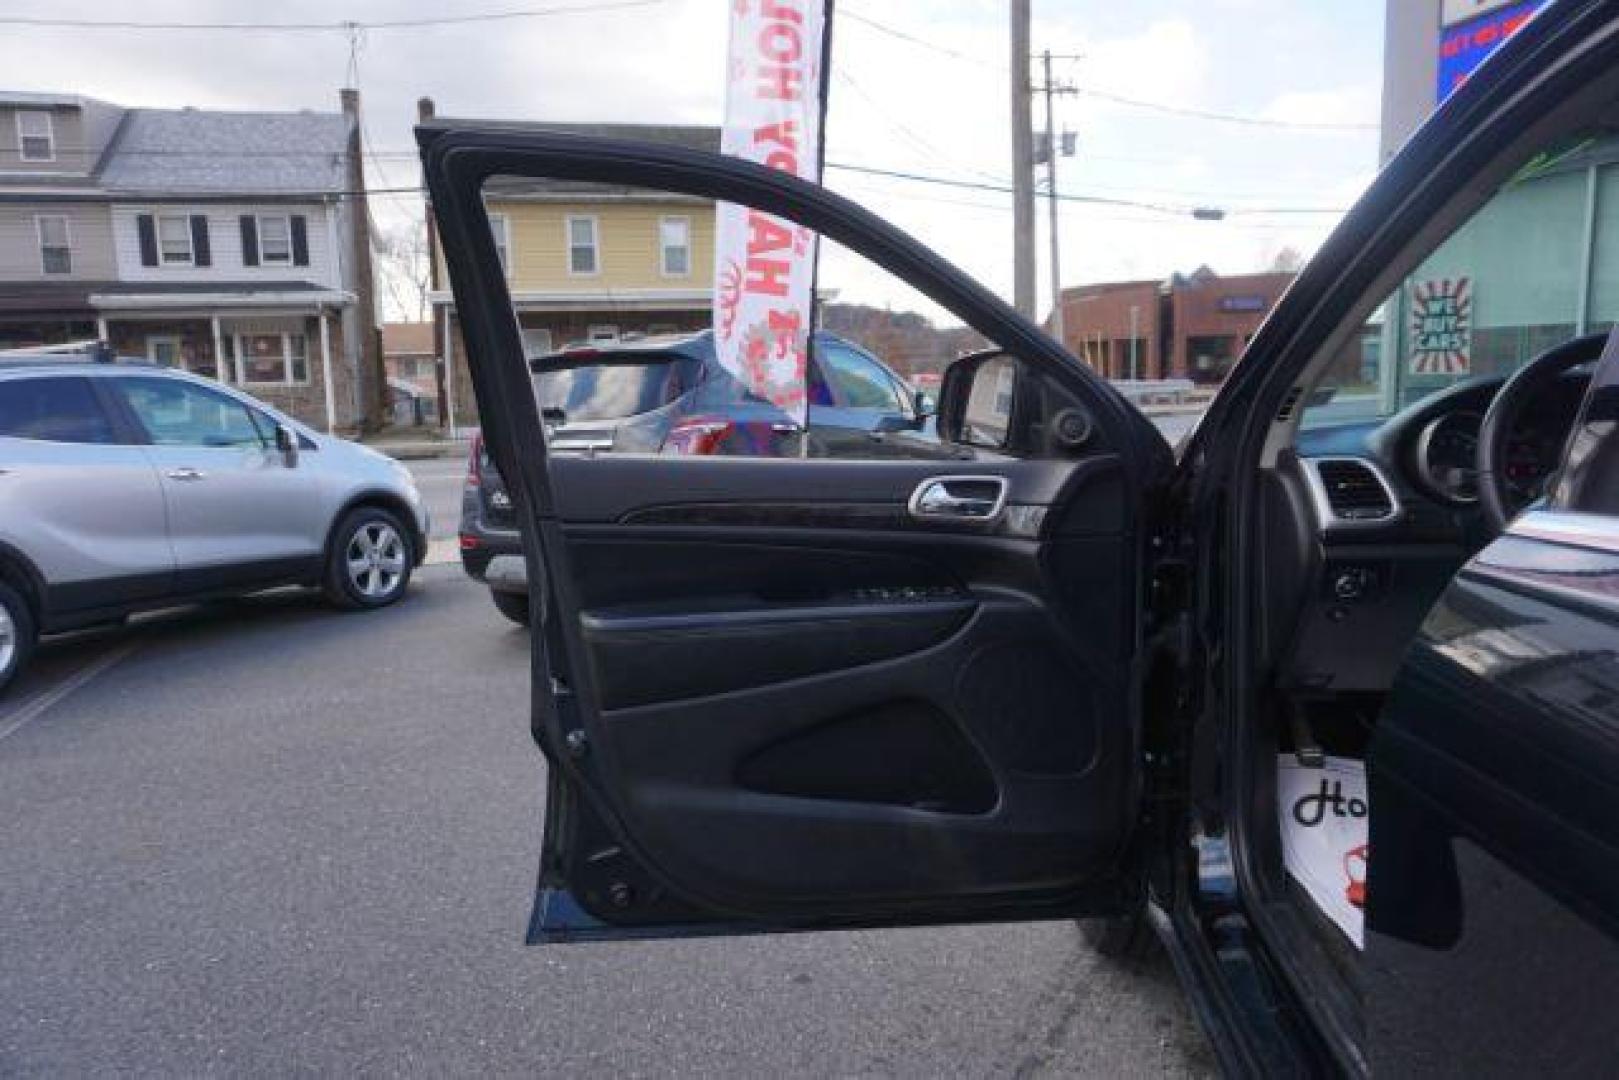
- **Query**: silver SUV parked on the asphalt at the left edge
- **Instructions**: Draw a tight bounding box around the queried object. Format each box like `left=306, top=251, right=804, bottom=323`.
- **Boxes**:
left=0, top=353, right=427, bottom=688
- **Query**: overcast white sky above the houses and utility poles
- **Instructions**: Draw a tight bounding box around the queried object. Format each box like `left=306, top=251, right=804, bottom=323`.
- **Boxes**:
left=0, top=0, right=1383, bottom=320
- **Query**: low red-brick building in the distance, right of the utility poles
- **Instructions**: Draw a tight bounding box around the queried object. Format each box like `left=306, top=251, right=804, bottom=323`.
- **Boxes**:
left=1047, top=267, right=1294, bottom=384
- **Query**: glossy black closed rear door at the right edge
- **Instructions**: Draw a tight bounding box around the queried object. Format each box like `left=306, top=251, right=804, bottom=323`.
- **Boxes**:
left=1365, top=330, right=1619, bottom=1075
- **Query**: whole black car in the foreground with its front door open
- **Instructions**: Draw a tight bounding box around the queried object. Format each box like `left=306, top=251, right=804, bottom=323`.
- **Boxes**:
left=419, top=0, right=1619, bottom=1075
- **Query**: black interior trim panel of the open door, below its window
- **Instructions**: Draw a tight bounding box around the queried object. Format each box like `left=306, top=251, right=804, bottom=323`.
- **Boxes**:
left=552, top=458, right=1130, bottom=913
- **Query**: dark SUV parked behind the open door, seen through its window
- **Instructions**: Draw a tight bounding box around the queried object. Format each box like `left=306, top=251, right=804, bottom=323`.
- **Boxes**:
left=460, top=330, right=958, bottom=625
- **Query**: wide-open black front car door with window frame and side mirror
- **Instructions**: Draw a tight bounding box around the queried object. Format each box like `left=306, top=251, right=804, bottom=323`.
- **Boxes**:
left=418, top=126, right=1171, bottom=941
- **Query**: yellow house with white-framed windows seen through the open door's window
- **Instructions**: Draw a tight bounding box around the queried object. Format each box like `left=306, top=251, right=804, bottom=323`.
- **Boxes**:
left=423, top=114, right=719, bottom=427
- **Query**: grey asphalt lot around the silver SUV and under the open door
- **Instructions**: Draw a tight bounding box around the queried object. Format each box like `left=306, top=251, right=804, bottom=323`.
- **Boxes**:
left=0, top=569, right=1213, bottom=1077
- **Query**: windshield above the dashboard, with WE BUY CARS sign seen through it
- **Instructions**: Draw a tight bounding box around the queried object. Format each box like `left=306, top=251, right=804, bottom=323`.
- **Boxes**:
left=1302, top=136, right=1619, bottom=427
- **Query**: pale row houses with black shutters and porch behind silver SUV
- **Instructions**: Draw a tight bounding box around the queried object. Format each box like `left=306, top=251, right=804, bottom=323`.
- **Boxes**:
left=0, top=91, right=382, bottom=432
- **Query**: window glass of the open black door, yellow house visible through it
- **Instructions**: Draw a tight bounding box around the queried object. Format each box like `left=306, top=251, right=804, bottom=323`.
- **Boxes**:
left=472, top=176, right=989, bottom=458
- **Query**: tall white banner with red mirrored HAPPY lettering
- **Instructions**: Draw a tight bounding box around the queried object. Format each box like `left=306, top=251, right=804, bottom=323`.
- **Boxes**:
left=714, top=0, right=826, bottom=427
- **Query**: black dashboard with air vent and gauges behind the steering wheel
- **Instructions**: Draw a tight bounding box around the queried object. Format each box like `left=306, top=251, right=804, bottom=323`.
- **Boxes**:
left=1263, top=374, right=1588, bottom=693
